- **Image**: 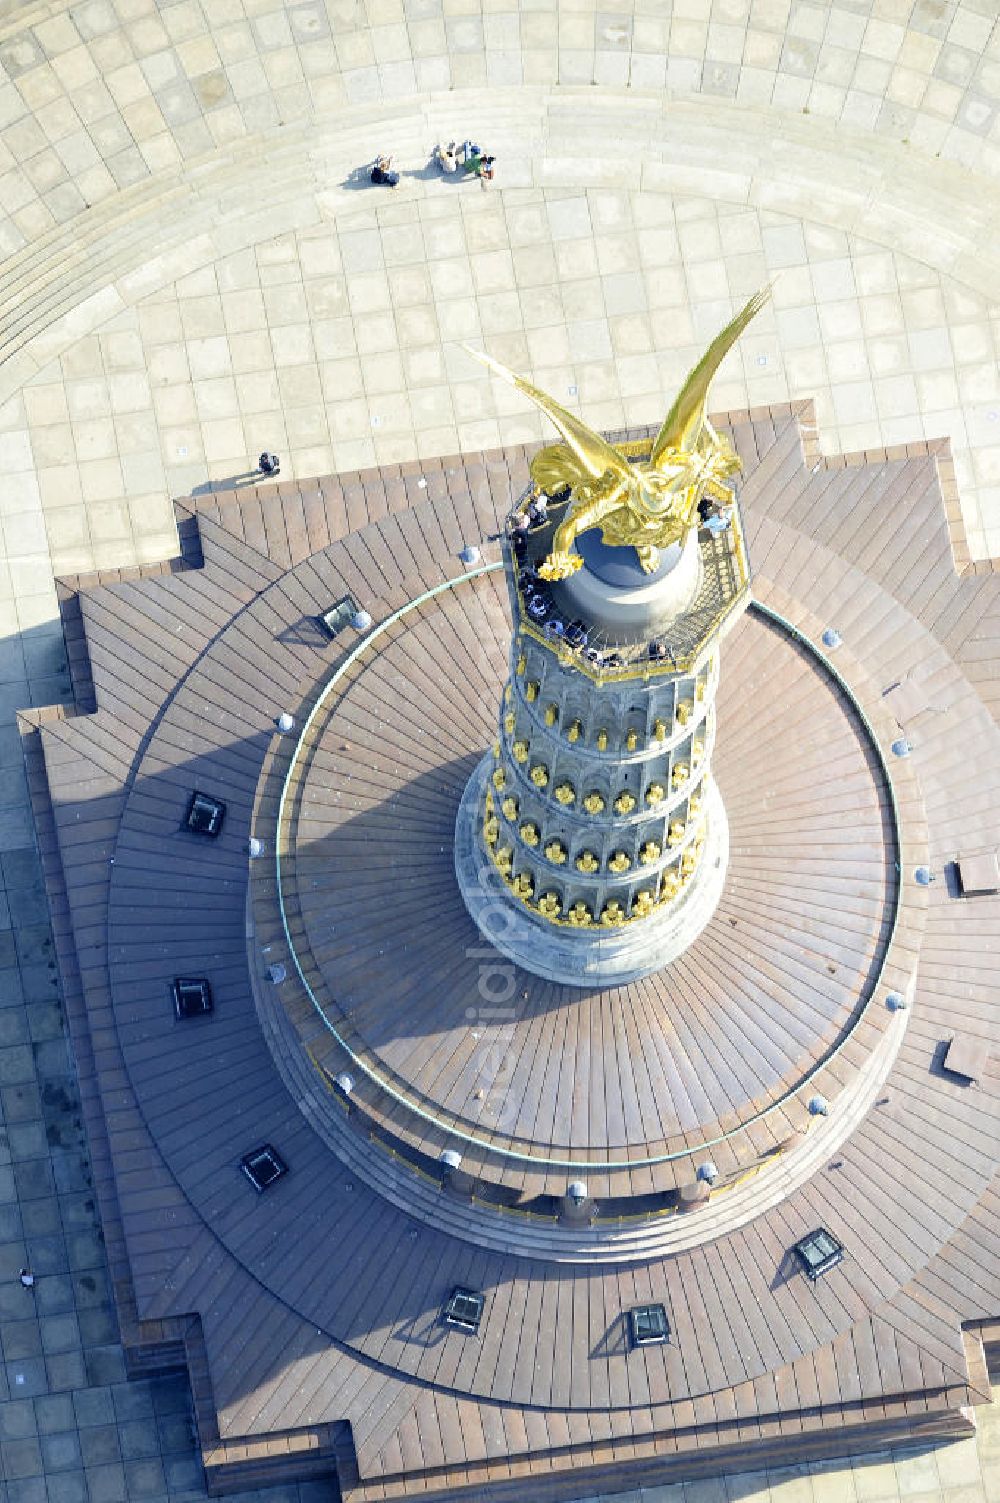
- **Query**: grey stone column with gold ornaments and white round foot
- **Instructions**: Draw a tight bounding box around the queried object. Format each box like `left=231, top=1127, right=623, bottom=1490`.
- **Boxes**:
left=456, top=517, right=739, bottom=986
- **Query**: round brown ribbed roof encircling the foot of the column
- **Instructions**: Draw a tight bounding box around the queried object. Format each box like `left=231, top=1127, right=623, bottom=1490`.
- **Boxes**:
left=281, top=576, right=898, bottom=1180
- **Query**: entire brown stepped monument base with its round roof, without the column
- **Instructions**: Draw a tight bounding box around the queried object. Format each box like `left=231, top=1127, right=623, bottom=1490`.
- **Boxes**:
left=23, top=409, right=1000, bottom=1503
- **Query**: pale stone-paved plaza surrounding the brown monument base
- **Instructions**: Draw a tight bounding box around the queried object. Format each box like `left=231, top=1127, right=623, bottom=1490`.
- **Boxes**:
left=0, top=0, right=1000, bottom=1503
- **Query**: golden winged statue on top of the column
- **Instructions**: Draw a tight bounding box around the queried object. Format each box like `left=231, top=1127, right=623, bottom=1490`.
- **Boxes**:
left=466, top=287, right=770, bottom=579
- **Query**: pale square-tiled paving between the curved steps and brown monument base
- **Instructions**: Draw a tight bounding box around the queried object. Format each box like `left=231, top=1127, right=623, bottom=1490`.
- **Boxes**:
left=0, top=180, right=1000, bottom=610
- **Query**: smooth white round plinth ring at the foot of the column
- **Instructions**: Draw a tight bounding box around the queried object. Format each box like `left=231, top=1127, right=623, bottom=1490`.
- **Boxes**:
left=454, top=753, right=729, bottom=987
